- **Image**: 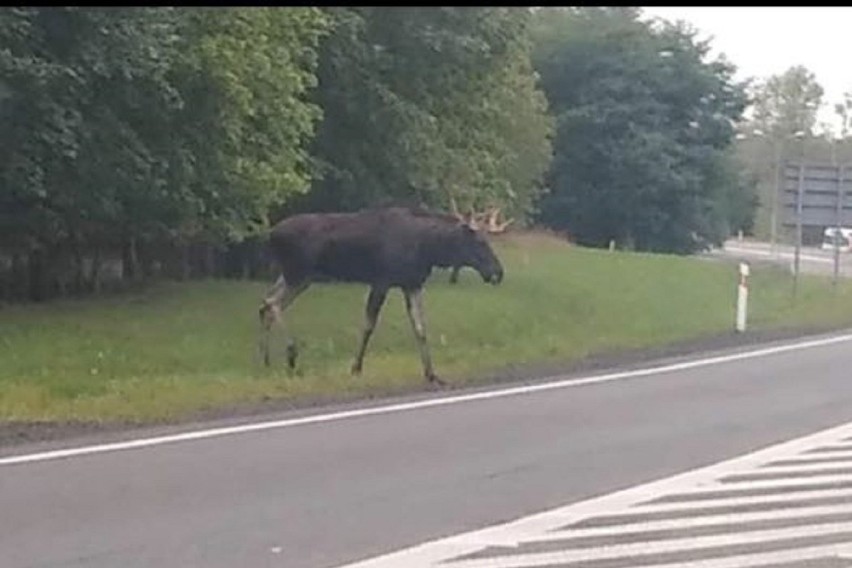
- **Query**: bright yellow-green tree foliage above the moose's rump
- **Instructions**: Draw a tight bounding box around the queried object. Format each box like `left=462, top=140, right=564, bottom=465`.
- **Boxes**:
left=174, top=8, right=327, bottom=239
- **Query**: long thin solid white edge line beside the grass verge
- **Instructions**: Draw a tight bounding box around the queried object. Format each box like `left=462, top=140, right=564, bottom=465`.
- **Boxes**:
left=5, top=333, right=852, bottom=466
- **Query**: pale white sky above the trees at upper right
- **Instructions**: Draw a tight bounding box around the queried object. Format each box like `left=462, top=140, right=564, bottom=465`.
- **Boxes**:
left=642, top=6, right=852, bottom=133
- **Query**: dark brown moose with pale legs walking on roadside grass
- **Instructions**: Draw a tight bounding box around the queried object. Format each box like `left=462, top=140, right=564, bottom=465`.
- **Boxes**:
left=259, top=206, right=503, bottom=385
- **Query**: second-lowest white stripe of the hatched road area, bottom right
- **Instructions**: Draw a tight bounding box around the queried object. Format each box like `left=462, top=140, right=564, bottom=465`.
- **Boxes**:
left=447, top=522, right=852, bottom=568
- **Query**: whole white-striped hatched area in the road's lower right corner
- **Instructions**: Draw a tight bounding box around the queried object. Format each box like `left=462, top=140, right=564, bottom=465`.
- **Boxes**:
left=341, top=423, right=852, bottom=568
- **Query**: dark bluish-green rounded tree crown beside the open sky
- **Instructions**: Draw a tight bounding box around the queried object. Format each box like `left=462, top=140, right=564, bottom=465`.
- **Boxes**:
left=535, top=8, right=746, bottom=252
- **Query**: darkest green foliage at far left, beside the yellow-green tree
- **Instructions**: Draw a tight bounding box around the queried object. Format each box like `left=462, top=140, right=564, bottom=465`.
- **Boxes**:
left=0, top=8, right=177, bottom=251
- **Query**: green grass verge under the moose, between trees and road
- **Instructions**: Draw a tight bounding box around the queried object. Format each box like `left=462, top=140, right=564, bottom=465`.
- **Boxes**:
left=0, top=236, right=852, bottom=422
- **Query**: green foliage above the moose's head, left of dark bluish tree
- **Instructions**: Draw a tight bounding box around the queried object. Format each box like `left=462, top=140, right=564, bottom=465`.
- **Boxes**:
left=300, top=8, right=550, bottom=222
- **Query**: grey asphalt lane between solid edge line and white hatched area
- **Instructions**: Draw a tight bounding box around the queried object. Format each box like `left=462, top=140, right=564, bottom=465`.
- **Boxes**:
left=5, top=330, right=852, bottom=568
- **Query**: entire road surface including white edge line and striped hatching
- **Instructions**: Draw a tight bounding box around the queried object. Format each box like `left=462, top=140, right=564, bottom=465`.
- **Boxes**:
left=5, top=335, right=852, bottom=568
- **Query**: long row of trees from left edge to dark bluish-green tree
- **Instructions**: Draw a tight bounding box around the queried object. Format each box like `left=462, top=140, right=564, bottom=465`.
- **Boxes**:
left=0, top=7, right=553, bottom=304
